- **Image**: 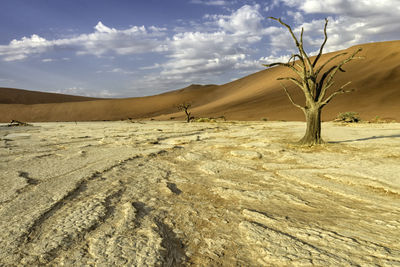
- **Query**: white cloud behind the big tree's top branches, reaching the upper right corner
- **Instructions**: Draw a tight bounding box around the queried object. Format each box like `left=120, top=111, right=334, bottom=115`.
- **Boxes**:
left=271, top=0, right=400, bottom=52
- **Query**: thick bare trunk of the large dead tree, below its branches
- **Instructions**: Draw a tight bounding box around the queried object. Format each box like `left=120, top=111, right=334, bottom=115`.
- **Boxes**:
left=299, top=107, right=324, bottom=146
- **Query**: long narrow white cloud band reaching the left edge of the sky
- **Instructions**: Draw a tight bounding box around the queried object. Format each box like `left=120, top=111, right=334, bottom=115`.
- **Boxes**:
left=0, top=21, right=165, bottom=61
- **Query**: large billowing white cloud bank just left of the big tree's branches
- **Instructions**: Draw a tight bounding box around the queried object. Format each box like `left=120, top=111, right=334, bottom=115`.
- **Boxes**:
left=139, top=5, right=266, bottom=91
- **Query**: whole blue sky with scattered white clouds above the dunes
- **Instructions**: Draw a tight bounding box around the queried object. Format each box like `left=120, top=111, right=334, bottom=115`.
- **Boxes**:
left=0, top=0, right=400, bottom=97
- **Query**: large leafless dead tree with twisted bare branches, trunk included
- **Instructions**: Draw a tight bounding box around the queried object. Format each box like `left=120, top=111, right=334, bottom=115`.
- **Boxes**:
left=264, top=17, right=362, bottom=146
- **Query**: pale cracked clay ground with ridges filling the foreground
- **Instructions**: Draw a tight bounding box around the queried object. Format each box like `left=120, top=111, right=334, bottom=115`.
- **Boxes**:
left=0, top=121, right=400, bottom=266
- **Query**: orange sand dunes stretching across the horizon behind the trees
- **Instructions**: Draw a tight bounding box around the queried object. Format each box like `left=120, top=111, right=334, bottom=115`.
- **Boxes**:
left=0, top=41, right=400, bottom=122
